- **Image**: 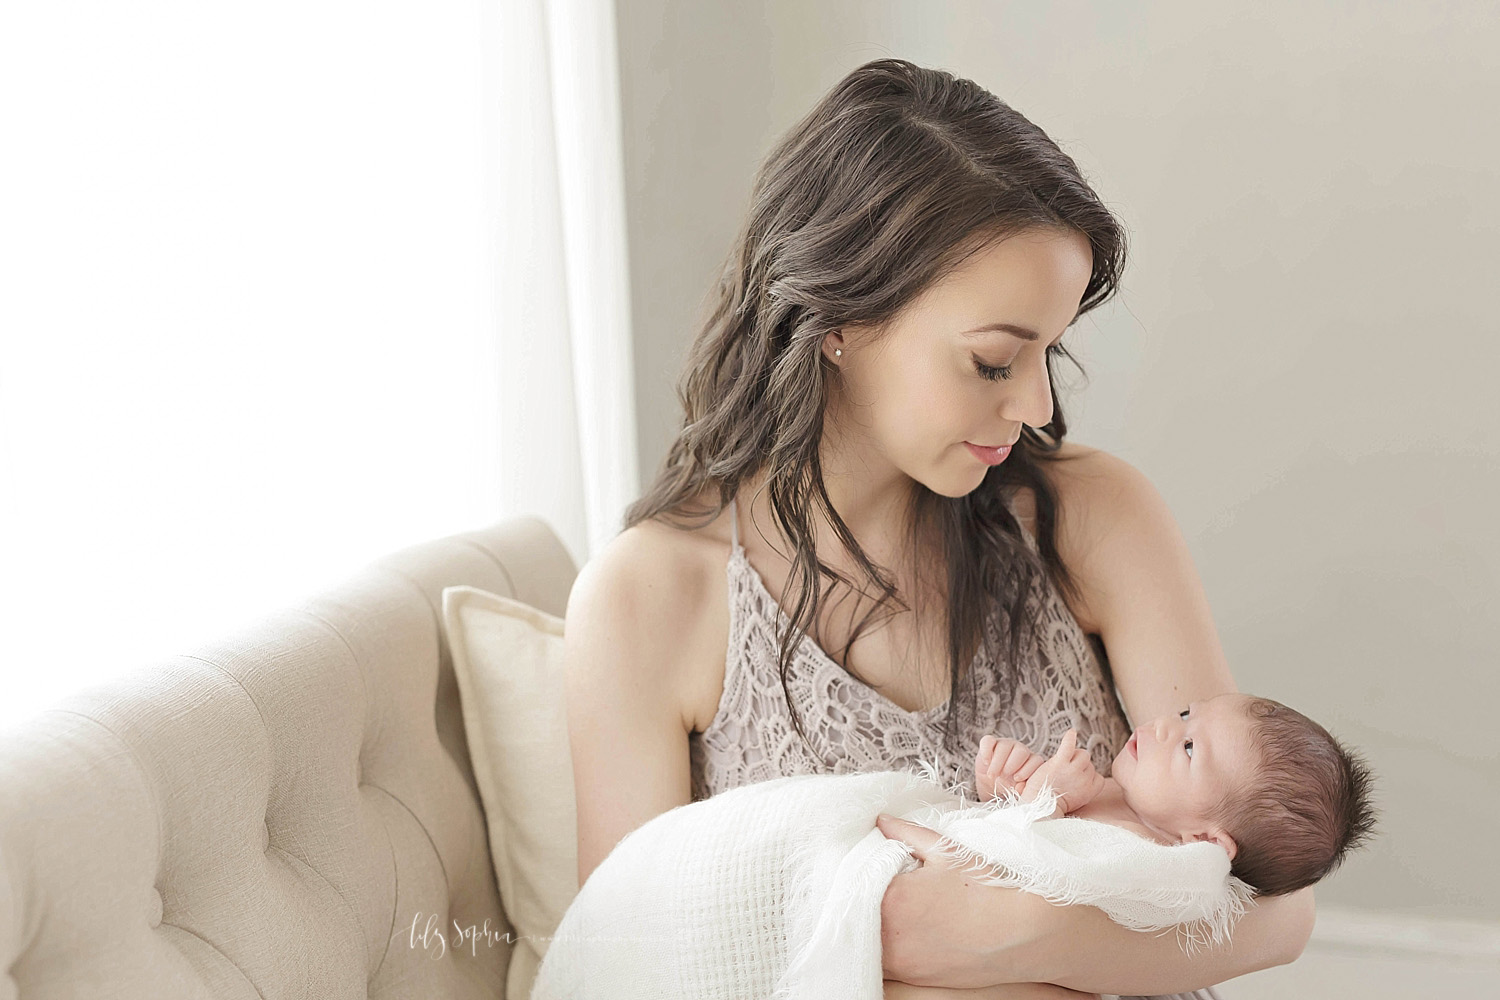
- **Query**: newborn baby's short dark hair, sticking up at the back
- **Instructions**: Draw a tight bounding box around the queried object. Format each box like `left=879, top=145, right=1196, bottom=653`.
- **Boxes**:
left=1217, top=697, right=1376, bottom=897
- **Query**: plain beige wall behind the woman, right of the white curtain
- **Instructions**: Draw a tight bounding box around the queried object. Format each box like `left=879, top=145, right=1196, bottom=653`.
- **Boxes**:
left=618, top=0, right=1500, bottom=918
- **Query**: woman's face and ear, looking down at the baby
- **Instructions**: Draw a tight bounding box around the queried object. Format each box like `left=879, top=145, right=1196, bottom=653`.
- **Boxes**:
left=824, top=229, right=1094, bottom=496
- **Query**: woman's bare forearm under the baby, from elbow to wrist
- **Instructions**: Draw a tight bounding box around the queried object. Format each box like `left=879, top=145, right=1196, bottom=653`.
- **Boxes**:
left=1013, top=888, right=1316, bottom=996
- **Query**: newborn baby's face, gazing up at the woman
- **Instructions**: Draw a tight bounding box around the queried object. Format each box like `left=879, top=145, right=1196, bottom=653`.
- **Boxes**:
left=1110, top=694, right=1256, bottom=858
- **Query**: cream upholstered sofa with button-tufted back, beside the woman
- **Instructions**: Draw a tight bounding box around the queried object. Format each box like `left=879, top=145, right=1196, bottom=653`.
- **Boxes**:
left=0, top=517, right=576, bottom=1000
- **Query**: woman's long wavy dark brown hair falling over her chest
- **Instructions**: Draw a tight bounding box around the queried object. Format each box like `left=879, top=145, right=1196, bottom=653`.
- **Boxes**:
left=624, top=58, right=1125, bottom=747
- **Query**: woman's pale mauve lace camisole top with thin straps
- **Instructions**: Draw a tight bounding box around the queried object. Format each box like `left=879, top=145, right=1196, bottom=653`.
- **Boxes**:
left=689, top=501, right=1130, bottom=801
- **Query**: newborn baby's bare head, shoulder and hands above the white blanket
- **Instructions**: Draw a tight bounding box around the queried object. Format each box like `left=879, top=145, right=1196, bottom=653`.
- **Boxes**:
left=975, top=694, right=1374, bottom=895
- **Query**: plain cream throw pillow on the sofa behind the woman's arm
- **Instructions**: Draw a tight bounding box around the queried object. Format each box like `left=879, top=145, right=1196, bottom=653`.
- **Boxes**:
left=443, top=586, right=578, bottom=1000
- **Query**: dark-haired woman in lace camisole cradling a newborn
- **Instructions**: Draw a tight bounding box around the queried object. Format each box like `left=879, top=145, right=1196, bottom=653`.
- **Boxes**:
left=564, top=60, right=1313, bottom=999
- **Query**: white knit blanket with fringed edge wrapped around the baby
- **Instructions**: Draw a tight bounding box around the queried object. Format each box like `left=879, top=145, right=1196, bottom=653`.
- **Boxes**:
left=531, top=771, right=1251, bottom=1000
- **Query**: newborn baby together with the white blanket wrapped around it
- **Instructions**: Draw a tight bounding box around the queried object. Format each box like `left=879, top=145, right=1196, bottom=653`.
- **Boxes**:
left=531, top=694, right=1373, bottom=1000
